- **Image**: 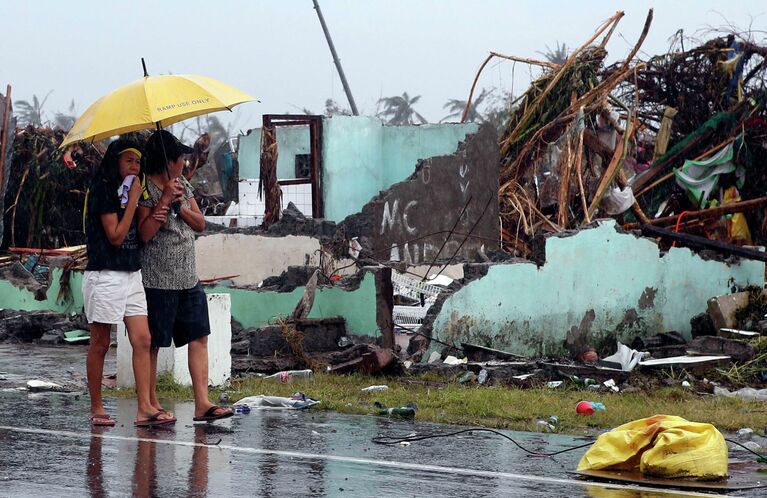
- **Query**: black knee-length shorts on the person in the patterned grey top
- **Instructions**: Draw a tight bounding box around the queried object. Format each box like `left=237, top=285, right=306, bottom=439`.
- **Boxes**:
left=145, top=282, right=210, bottom=348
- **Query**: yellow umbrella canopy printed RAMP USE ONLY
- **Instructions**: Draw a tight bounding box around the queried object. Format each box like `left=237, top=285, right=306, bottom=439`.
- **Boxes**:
left=61, top=74, right=257, bottom=147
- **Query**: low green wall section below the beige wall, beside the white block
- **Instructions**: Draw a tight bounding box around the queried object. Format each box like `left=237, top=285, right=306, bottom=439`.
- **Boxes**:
left=206, top=273, right=381, bottom=337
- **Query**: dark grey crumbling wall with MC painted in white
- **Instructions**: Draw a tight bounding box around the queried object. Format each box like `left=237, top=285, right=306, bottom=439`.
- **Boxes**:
left=339, top=126, right=500, bottom=265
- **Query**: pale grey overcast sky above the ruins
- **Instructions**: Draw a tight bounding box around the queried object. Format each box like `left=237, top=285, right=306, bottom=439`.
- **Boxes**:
left=0, top=0, right=767, bottom=130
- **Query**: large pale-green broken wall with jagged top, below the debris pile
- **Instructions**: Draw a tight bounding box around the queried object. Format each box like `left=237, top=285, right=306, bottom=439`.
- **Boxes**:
left=426, top=220, right=765, bottom=357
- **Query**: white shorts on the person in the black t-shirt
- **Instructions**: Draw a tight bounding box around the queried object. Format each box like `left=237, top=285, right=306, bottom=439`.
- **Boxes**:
left=83, top=270, right=146, bottom=324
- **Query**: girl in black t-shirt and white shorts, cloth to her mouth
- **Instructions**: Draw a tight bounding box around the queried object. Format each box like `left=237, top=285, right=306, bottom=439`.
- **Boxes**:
left=83, top=139, right=176, bottom=426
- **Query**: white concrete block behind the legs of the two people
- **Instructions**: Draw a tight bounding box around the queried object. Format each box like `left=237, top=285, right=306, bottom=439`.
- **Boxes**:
left=117, top=294, right=232, bottom=387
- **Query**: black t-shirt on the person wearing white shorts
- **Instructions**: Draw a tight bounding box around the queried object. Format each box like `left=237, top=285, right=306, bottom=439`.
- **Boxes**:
left=85, top=179, right=141, bottom=271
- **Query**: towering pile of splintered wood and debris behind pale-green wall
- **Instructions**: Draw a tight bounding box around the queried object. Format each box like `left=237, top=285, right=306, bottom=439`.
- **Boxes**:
left=470, top=11, right=767, bottom=258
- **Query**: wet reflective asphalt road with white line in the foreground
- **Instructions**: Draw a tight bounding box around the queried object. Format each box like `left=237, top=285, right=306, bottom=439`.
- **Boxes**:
left=0, top=345, right=763, bottom=497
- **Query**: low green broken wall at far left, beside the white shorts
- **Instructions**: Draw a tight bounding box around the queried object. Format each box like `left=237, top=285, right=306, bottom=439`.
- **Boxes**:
left=0, top=268, right=83, bottom=313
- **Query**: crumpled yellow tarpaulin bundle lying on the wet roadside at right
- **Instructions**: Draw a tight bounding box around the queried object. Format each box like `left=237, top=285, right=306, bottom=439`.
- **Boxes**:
left=578, top=415, right=727, bottom=479
